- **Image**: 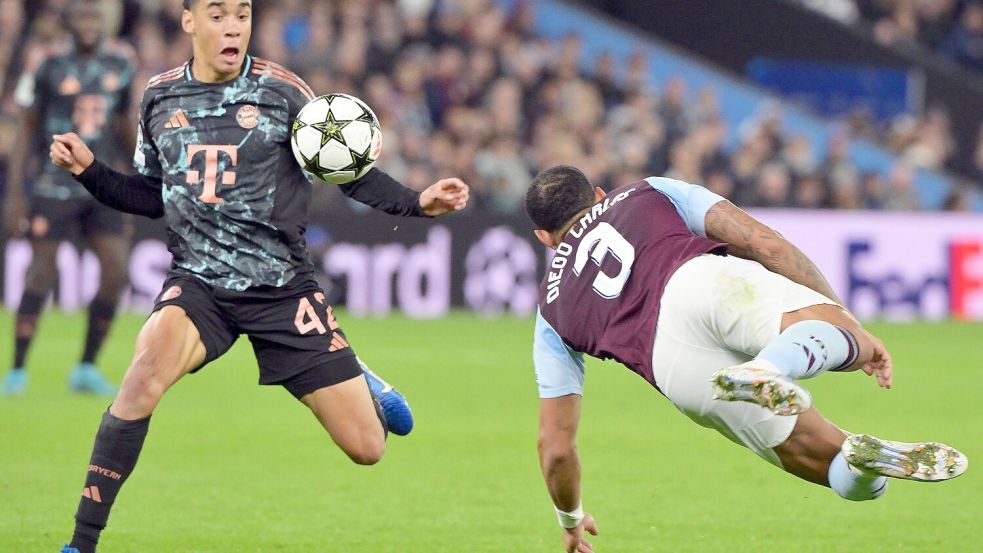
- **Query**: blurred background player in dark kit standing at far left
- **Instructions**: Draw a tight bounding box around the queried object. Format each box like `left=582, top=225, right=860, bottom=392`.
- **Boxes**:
left=0, top=0, right=135, bottom=395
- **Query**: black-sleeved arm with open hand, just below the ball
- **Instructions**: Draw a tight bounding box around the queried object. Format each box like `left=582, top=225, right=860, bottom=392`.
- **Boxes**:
left=339, top=168, right=469, bottom=217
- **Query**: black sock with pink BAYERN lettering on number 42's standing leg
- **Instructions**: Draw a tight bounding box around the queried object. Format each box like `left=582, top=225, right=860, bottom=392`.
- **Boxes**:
left=70, top=411, right=150, bottom=553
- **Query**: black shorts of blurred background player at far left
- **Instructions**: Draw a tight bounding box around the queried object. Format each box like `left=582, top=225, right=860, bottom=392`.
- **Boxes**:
left=31, top=196, right=126, bottom=241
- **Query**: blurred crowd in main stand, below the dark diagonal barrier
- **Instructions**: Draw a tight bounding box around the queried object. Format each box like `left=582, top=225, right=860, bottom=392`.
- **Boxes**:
left=0, top=0, right=983, bottom=213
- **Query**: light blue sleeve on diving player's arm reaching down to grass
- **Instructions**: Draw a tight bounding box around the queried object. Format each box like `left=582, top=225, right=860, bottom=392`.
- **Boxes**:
left=532, top=310, right=584, bottom=399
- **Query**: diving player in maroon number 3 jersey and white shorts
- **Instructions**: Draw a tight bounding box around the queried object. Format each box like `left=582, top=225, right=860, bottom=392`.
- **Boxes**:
left=526, top=166, right=967, bottom=553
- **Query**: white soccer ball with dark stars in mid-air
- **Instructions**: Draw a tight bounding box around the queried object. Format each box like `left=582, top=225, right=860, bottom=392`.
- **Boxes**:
left=290, top=94, right=382, bottom=184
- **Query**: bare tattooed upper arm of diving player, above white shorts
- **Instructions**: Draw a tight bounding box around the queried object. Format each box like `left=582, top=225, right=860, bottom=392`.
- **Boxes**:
left=706, top=202, right=843, bottom=305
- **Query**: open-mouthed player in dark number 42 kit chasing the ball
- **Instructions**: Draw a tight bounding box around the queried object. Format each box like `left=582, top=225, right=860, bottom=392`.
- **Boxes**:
left=50, top=0, right=468, bottom=553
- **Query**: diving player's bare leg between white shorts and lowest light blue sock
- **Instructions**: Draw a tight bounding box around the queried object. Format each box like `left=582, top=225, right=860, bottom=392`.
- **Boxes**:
left=774, top=407, right=847, bottom=486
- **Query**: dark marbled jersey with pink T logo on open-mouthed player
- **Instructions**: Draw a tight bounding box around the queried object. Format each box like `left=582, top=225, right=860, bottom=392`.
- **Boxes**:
left=134, top=56, right=314, bottom=290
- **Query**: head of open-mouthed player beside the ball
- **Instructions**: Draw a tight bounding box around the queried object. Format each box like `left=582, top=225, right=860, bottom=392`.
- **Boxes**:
left=182, top=0, right=253, bottom=82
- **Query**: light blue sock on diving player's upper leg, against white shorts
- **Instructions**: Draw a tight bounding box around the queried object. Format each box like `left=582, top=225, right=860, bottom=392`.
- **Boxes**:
left=757, top=321, right=860, bottom=379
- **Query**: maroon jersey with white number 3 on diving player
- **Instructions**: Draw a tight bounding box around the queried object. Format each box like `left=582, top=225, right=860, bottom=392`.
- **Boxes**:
left=535, top=177, right=726, bottom=389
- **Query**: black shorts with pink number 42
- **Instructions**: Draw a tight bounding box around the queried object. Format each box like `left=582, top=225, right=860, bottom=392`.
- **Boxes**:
left=148, top=273, right=362, bottom=399
